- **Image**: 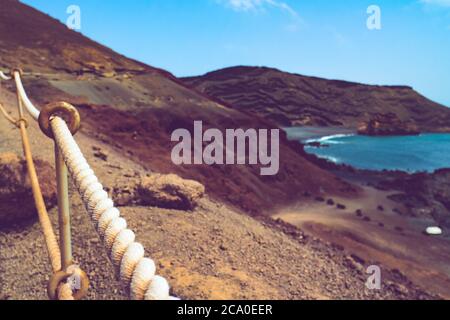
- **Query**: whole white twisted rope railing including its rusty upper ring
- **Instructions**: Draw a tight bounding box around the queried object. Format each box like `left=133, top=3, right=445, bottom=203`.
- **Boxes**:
left=0, top=70, right=177, bottom=300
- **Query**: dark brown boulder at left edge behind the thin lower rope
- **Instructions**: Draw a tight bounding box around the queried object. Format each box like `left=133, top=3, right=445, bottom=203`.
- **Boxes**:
left=0, top=153, right=57, bottom=228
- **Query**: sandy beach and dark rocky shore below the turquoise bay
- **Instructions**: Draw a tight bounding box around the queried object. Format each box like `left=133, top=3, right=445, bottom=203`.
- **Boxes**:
left=272, top=131, right=450, bottom=299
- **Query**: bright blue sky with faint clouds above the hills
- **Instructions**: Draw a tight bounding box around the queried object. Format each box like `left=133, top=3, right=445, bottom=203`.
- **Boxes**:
left=22, top=0, right=450, bottom=106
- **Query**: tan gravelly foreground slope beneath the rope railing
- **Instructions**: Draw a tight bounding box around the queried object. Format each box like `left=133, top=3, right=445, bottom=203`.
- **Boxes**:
left=0, top=84, right=436, bottom=300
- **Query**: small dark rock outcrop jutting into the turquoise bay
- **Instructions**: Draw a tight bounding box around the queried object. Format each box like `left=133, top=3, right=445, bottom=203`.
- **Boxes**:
left=358, top=113, right=420, bottom=136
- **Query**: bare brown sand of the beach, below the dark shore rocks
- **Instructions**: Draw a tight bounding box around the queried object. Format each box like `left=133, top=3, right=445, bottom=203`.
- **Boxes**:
left=275, top=187, right=450, bottom=299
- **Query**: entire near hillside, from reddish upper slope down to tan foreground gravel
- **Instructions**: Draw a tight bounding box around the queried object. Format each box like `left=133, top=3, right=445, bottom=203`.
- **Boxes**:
left=0, top=0, right=439, bottom=299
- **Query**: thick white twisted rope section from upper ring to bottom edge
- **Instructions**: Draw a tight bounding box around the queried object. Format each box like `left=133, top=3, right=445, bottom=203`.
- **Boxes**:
left=50, top=117, right=176, bottom=300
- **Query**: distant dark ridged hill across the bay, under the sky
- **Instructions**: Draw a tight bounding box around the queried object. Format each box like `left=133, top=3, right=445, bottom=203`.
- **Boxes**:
left=183, top=67, right=450, bottom=132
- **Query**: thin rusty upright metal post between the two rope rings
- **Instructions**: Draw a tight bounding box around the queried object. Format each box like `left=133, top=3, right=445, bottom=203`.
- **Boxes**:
left=55, top=143, right=73, bottom=270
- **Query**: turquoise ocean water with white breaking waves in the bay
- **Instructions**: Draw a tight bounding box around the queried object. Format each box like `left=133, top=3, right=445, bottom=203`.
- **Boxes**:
left=286, top=128, right=450, bottom=172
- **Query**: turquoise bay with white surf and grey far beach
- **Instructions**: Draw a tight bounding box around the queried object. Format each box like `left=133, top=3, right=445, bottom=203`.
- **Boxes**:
left=283, top=126, right=450, bottom=174
